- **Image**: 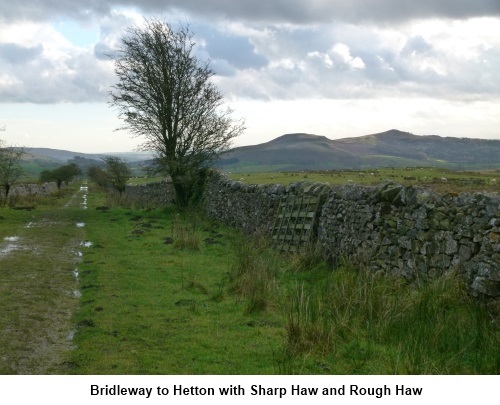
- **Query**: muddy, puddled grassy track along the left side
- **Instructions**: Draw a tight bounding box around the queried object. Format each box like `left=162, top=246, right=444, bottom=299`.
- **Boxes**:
left=0, top=186, right=87, bottom=374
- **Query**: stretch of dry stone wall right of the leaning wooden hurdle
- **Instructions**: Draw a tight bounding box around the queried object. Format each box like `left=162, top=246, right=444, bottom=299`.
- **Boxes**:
left=318, top=183, right=500, bottom=297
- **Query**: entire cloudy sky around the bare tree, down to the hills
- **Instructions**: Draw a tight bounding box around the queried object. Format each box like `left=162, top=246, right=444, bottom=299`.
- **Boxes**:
left=0, top=0, right=500, bottom=153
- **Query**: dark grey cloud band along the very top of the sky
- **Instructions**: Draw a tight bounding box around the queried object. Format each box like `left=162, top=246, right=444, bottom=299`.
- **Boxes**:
left=0, top=0, right=500, bottom=24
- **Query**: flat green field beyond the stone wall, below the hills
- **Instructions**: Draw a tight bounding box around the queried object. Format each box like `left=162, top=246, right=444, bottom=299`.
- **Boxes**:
left=228, top=167, right=500, bottom=193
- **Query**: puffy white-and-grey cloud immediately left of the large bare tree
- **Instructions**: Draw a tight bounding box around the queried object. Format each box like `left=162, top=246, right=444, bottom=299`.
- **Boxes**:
left=0, top=23, right=115, bottom=103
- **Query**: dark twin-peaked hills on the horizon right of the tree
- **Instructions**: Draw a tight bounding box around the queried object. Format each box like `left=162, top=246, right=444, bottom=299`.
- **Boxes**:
left=218, top=129, right=500, bottom=172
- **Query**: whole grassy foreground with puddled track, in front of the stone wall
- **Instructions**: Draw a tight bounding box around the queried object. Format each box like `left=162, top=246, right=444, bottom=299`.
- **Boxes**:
left=0, top=181, right=500, bottom=375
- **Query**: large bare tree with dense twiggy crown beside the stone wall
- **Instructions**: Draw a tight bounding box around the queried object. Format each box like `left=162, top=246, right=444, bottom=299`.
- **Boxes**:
left=110, top=19, right=244, bottom=206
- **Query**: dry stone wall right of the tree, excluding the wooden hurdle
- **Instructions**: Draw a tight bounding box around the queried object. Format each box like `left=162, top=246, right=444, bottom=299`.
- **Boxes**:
left=205, top=172, right=500, bottom=298
